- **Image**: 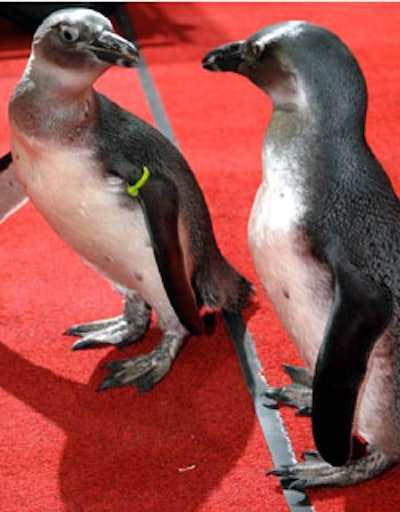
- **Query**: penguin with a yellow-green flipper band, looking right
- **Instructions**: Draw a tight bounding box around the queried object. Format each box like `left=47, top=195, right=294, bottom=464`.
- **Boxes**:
left=9, top=8, right=252, bottom=393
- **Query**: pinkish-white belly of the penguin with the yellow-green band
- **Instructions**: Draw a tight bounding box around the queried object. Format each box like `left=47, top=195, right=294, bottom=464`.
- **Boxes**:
left=12, top=134, right=172, bottom=316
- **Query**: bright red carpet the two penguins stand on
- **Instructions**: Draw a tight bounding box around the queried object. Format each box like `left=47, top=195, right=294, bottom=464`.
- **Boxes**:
left=0, top=3, right=400, bottom=512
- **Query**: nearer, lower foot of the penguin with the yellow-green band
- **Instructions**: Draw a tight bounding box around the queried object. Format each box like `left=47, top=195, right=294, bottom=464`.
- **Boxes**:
left=98, top=334, right=185, bottom=395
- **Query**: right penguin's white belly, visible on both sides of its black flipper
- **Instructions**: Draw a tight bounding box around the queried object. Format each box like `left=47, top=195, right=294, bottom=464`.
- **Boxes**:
left=249, top=180, right=400, bottom=452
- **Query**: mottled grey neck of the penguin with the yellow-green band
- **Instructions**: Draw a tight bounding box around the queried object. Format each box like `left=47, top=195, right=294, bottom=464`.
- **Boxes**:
left=10, top=55, right=96, bottom=140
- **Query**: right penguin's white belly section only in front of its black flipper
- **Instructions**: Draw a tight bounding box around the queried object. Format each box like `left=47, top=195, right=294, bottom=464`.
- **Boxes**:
left=249, top=183, right=332, bottom=370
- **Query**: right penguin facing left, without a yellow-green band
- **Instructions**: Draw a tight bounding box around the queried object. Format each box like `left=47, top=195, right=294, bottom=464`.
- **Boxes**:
left=203, top=20, right=400, bottom=490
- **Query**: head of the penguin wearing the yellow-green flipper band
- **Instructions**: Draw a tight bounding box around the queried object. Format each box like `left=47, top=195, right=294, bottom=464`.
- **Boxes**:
left=29, top=8, right=139, bottom=87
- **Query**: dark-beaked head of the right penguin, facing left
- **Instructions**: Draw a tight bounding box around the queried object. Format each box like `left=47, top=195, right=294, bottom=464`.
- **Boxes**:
left=203, top=21, right=366, bottom=122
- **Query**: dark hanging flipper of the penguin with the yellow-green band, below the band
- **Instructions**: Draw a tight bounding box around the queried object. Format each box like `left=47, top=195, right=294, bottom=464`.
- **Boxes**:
left=138, top=175, right=204, bottom=334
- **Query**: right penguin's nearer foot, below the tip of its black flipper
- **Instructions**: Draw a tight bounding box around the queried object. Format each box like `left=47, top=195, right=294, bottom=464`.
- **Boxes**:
left=267, top=450, right=394, bottom=491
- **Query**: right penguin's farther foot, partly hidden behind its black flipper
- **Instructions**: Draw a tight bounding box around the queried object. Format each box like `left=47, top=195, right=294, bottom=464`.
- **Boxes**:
left=265, top=365, right=313, bottom=416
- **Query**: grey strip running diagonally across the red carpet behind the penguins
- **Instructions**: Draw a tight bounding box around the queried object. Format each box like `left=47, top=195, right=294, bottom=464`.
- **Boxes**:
left=117, top=6, right=315, bottom=512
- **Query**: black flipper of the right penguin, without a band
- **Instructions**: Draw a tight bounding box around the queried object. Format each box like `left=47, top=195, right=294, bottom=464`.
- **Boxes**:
left=312, top=244, right=392, bottom=466
